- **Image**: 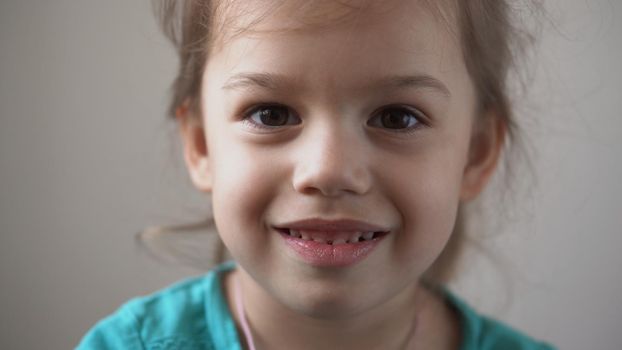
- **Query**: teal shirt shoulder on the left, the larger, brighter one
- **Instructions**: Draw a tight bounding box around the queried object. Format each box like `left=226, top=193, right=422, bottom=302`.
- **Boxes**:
left=77, top=267, right=235, bottom=350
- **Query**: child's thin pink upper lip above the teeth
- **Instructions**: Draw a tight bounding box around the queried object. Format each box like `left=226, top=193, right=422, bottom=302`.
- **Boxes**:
left=275, top=218, right=389, bottom=232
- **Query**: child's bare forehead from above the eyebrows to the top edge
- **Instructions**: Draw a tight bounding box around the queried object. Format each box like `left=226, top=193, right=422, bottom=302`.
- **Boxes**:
left=208, top=0, right=466, bottom=101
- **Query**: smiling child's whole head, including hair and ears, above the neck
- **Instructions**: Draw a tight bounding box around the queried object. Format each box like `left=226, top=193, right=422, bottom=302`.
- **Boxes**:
left=158, top=0, right=532, bottom=314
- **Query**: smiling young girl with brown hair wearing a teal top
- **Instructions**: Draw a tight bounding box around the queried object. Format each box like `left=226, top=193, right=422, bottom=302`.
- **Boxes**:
left=78, top=0, right=551, bottom=350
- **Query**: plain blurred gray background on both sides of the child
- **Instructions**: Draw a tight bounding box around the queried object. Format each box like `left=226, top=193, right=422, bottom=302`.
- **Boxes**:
left=0, top=0, right=622, bottom=349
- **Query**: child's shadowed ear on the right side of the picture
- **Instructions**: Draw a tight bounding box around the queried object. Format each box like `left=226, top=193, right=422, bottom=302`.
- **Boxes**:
left=460, top=110, right=507, bottom=201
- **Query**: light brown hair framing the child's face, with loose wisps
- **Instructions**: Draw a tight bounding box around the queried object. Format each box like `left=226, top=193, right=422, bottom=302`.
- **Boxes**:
left=141, top=0, right=541, bottom=284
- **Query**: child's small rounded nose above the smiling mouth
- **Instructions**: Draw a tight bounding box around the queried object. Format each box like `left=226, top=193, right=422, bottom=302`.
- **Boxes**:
left=293, top=126, right=371, bottom=197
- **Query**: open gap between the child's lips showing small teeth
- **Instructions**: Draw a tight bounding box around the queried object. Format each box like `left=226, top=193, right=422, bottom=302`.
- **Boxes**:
left=277, top=228, right=389, bottom=246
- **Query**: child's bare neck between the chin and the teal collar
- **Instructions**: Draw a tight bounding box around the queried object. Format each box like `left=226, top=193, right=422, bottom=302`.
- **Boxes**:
left=225, top=269, right=438, bottom=350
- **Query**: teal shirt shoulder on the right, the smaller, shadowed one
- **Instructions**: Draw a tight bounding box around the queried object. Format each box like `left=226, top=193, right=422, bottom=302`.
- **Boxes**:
left=443, top=290, right=554, bottom=350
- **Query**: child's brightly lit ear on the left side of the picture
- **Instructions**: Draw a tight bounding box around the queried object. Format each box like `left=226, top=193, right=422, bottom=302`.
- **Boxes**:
left=176, top=104, right=212, bottom=192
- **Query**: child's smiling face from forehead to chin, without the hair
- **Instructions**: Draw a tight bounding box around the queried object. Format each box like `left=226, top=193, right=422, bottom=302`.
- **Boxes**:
left=187, top=1, right=502, bottom=317
